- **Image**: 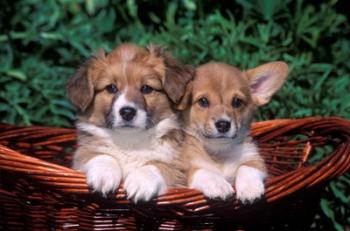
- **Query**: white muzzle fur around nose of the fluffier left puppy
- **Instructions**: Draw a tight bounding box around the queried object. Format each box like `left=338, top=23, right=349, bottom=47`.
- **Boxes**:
left=112, top=91, right=147, bottom=130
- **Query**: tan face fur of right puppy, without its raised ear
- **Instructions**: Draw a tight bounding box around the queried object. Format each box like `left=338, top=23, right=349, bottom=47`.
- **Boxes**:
left=179, top=63, right=255, bottom=139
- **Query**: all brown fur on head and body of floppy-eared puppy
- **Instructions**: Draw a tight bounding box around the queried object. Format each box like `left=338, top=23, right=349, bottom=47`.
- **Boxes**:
left=67, top=44, right=194, bottom=195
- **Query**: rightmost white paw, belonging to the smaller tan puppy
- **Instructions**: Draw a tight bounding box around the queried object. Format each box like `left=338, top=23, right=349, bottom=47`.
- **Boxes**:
left=236, top=166, right=265, bottom=203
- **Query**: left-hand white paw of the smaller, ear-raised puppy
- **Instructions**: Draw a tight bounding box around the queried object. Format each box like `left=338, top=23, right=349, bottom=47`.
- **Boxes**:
left=190, top=169, right=233, bottom=200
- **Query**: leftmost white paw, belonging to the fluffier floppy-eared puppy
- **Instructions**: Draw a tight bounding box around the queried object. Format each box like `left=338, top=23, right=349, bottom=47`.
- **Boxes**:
left=83, top=155, right=122, bottom=196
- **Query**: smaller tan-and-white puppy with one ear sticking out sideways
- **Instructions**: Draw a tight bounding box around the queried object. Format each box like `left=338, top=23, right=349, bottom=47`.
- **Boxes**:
left=178, top=62, right=288, bottom=202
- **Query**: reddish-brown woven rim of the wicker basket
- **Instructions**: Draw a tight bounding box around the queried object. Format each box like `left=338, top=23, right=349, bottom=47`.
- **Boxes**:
left=0, top=117, right=350, bottom=208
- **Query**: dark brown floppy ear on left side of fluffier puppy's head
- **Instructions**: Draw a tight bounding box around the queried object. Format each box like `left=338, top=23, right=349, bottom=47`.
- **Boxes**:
left=66, top=49, right=105, bottom=112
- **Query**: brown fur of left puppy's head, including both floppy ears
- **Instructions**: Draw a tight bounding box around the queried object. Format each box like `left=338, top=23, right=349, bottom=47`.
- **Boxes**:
left=67, top=44, right=193, bottom=126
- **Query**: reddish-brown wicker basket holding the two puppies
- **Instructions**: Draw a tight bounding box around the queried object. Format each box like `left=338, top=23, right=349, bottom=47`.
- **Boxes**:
left=0, top=117, right=350, bottom=230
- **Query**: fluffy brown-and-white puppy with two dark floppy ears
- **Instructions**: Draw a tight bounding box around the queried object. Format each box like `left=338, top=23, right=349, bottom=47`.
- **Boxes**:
left=67, top=44, right=193, bottom=202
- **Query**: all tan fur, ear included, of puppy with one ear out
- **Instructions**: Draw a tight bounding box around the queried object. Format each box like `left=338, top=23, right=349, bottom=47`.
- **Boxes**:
left=178, top=62, right=288, bottom=200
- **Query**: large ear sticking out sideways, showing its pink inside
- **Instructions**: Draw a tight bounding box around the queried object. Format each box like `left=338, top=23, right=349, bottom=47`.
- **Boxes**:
left=245, top=61, right=288, bottom=106
